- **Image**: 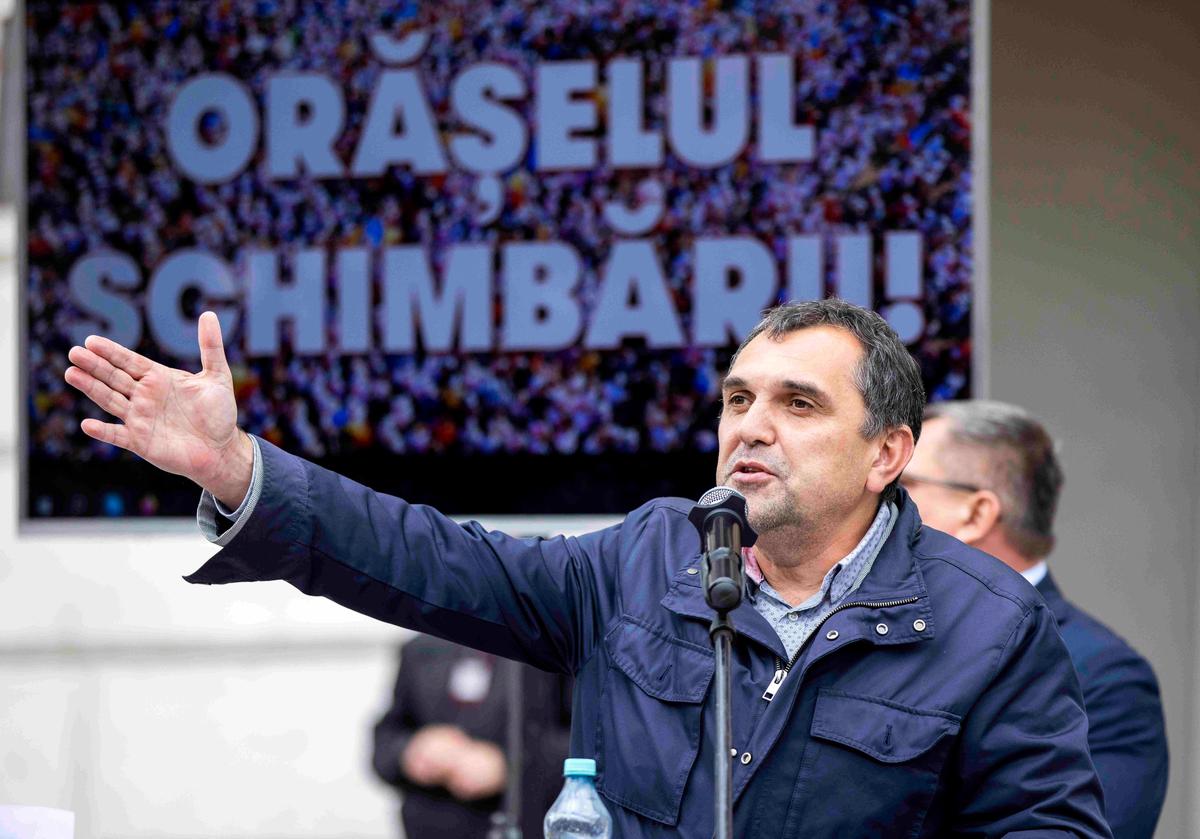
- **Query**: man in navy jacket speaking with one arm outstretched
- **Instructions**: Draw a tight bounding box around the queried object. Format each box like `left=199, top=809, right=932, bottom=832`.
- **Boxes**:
left=66, top=300, right=1111, bottom=839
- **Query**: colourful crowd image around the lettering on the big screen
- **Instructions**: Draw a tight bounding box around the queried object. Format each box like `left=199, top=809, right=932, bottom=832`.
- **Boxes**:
left=25, top=0, right=973, bottom=517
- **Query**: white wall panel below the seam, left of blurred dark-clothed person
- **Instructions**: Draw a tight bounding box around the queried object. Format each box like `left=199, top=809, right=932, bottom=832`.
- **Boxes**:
left=89, top=647, right=395, bottom=839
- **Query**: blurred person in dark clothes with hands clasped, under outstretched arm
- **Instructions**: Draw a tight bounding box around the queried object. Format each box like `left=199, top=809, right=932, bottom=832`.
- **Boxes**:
left=372, top=635, right=571, bottom=839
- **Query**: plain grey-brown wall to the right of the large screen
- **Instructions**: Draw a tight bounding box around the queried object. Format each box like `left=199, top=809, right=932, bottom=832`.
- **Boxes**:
left=988, top=0, right=1200, bottom=837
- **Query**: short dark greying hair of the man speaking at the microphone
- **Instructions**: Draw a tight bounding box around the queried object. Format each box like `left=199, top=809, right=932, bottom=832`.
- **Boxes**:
left=730, top=298, right=925, bottom=501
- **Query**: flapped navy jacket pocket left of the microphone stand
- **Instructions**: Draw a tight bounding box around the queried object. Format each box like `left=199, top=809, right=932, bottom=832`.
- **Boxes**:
left=596, top=617, right=713, bottom=825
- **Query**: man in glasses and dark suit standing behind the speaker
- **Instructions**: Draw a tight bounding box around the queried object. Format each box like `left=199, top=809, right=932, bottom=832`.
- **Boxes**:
left=901, top=401, right=1168, bottom=839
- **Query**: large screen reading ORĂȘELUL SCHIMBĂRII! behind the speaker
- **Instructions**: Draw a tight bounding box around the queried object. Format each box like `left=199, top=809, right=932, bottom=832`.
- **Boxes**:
left=23, top=0, right=977, bottom=519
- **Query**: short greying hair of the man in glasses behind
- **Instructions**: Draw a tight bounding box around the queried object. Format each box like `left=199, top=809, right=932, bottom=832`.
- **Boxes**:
left=925, top=400, right=1063, bottom=558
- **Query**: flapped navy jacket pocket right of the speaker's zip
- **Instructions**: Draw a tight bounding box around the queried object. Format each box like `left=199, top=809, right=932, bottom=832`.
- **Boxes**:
left=784, top=688, right=962, bottom=837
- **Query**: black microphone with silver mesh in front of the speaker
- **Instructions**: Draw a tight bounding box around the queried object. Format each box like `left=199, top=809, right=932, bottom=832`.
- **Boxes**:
left=688, top=486, right=758, bottom=612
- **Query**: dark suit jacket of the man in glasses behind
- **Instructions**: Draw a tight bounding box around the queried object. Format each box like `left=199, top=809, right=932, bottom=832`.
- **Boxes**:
left=1038, top=574, right=1166, bottom=839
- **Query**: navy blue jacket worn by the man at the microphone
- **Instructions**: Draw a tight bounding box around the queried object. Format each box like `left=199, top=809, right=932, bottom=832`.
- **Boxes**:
left=188, top=443, right=1111, bottom=839
